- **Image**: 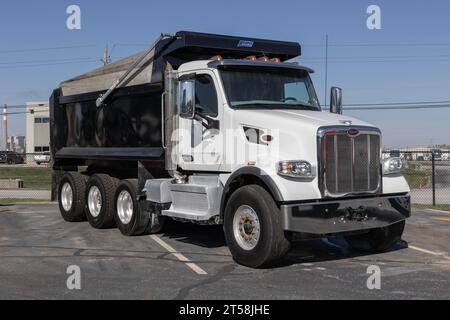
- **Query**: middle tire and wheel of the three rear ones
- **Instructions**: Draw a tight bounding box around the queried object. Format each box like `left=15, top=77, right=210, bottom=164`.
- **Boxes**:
left=86, top=174, right=118, bottom=229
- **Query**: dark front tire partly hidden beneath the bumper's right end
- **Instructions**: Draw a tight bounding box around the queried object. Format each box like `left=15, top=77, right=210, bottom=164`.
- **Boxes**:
left=345, top=221, right=406, bottom=253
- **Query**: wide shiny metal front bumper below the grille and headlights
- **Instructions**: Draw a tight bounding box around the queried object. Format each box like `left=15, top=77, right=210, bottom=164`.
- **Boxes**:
left=281, top=195, right=411, bottom=235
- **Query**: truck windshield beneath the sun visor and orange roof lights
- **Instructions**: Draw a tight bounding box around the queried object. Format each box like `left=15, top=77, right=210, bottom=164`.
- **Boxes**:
left=221, top=68, right=321, bottom=111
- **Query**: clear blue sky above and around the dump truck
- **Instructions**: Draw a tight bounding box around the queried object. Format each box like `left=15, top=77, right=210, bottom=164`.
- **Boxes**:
left=0, top=0, right=450, bottom=147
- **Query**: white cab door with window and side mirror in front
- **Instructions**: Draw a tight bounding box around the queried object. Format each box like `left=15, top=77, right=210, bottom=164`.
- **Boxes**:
left=178, top=71, right=224, bottom=172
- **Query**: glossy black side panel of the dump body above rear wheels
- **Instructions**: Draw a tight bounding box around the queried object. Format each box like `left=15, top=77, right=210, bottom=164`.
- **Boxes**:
left=51, top=87, right=164, bottom=163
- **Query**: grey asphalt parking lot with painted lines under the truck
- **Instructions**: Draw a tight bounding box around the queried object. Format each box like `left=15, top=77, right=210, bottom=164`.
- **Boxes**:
left=0, top=205, right=450, bottom=300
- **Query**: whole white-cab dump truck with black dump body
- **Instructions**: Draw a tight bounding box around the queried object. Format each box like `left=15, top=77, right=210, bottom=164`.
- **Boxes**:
left=50, top=31, right=411, bottom=268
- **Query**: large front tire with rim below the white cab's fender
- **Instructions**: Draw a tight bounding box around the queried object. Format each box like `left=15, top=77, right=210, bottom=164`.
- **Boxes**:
left=224, top=185, right=291, bottom=268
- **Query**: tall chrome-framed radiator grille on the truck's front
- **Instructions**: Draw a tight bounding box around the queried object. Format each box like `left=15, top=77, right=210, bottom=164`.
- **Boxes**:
left=319, top=127, right=381, bottom=197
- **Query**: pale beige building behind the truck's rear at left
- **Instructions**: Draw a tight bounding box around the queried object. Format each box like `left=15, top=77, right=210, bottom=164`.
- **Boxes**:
left=26, top=102, right=50, bottom=162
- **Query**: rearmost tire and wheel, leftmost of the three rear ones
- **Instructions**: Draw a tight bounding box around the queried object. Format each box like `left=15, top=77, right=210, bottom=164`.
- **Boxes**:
left=58, top=172, right=87, bottom=222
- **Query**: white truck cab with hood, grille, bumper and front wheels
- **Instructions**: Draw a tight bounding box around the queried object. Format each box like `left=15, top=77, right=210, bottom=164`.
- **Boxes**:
left=153, top=56, right=410, bottom=267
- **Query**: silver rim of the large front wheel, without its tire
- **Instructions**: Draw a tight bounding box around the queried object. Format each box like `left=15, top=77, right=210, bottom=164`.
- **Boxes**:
left=233, top=206, right=261, bottom=251
